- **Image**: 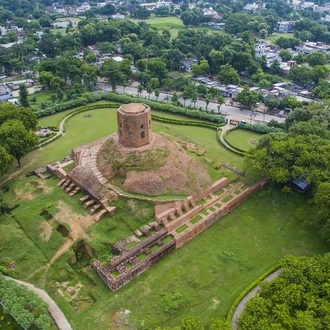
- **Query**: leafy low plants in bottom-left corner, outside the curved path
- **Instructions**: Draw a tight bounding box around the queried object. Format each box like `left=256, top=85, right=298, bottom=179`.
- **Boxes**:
left=0, top=275, right=52, bottom=330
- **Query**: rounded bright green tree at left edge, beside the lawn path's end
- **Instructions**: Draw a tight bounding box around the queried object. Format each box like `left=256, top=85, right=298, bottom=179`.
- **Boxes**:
left=0, top=120, right=38, bottom=166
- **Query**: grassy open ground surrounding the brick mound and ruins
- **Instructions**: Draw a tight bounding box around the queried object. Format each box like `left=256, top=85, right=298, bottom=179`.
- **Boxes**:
left=0, top=102, right=328, bottom=329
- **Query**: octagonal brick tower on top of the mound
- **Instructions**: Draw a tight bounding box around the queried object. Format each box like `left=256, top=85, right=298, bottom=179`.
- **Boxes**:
left=117, top=103, right=152, bottom=148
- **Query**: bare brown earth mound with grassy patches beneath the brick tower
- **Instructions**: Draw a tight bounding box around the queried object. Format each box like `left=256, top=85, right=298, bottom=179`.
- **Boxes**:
left=97, top=133, right=211, bottom=196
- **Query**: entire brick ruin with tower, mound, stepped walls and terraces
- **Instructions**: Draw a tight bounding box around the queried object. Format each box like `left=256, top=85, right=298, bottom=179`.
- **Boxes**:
left=43, top=103, right=266, bottom=291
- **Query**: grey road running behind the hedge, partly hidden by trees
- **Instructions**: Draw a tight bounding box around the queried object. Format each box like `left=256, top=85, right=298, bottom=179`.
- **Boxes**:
left=97, top=82, right=285, bottom=123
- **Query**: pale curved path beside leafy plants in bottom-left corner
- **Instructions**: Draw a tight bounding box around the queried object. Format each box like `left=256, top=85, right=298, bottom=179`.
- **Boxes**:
left=5, top=276, right=72, bottom=330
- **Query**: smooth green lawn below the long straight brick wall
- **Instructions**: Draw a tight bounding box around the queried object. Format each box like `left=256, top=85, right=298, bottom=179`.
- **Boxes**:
left=38, top=188, right=329, bottom=329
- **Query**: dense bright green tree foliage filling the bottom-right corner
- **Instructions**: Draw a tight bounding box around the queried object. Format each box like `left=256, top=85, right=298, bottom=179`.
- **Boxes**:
left=239, top=254, right=330, bottom=330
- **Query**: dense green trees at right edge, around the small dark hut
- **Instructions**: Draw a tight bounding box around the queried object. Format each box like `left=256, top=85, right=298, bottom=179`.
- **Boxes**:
left=245, top=103, right=330, bottom=240
